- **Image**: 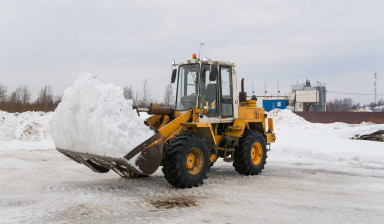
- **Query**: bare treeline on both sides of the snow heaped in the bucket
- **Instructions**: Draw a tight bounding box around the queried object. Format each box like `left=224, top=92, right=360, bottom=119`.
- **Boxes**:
left=0, top=80, right=175, bottom=113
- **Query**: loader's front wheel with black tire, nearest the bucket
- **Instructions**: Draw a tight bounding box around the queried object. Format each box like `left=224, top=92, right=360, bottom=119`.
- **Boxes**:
left=162, top=132, right=211, bottom=188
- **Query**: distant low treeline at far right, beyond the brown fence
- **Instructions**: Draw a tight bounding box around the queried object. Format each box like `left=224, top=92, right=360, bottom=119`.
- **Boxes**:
left=327, top=98, right=384, bottom=111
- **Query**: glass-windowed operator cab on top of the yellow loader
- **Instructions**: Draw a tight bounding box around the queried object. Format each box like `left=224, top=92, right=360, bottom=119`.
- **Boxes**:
left=172, top=59, right=238, bottom=123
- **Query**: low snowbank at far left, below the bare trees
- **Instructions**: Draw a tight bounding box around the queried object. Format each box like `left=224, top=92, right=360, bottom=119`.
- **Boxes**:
left=0, top=111, right=52, bottom=141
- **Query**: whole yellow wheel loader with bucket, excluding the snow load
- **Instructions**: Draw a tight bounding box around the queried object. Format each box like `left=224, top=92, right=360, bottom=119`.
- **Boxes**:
left=57, top=54, right=275, bottom=188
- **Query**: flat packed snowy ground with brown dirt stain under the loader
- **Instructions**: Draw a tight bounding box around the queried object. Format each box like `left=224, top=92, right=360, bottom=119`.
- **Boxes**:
left=0, top=149, right=384, bottom=223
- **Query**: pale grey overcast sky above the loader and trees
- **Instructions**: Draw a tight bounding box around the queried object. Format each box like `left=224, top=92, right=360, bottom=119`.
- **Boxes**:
left=0, top=0, right=384, bottom=103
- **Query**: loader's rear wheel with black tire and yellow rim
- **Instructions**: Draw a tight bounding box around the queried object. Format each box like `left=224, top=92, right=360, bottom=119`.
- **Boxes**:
left=233, top=130, right=267, bottom=176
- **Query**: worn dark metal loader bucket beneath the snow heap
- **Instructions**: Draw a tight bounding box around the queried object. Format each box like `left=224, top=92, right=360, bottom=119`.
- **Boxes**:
left=57, top=132, right=164, bottom=177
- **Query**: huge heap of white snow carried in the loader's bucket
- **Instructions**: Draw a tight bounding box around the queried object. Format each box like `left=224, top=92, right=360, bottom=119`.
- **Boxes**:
left=51, top=74, right=154, bottom=158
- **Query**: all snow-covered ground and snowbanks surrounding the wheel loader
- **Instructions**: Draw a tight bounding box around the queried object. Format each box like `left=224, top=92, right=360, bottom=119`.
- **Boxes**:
left=0, top=110, right=384, bottom=223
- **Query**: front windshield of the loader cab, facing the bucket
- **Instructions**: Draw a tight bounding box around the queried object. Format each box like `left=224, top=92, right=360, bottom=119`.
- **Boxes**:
left=176, top=64, right=200, bottom=110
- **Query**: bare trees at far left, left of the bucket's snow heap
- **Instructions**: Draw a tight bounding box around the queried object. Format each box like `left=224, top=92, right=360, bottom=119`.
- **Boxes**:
left=0, top=84, right=61, bottom=113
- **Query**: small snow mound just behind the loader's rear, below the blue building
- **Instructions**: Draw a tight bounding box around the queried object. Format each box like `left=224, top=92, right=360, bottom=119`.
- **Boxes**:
left=267, top=109, right=310, bottom=126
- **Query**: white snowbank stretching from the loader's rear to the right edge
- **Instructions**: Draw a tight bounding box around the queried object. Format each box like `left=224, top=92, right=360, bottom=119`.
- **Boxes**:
left=268, top=110, right=384, bottom=168
